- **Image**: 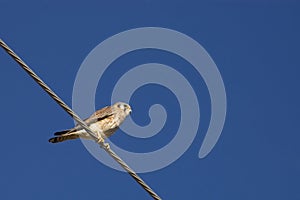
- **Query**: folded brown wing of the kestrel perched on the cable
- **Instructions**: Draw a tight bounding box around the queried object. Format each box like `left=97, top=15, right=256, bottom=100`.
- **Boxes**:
left=75, top=106, right=113, bottom=130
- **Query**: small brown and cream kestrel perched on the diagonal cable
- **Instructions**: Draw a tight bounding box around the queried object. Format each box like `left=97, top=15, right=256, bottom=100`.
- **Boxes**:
left=49, top=102, right=131, bottom=143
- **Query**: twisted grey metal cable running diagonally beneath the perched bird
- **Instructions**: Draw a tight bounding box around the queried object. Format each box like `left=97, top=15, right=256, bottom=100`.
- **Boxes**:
left=0, top=39, right=161, bottom=199
